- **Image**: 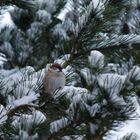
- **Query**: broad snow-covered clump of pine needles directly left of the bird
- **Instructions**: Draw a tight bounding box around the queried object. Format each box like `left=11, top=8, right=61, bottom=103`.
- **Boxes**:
left=1, top=66, right=44, bottom=108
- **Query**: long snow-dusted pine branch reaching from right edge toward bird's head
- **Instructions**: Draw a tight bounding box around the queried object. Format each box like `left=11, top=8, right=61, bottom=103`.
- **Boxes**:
left=63, top=35, right=140, bottom=68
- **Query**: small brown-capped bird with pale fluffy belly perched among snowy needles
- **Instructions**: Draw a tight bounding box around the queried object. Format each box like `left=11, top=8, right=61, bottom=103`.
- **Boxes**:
left=43, top=63, right=65, bottom=93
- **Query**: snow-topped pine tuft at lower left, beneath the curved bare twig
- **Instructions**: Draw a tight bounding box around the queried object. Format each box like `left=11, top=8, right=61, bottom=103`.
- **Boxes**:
left=12, top=111, right=46, bottom=140
